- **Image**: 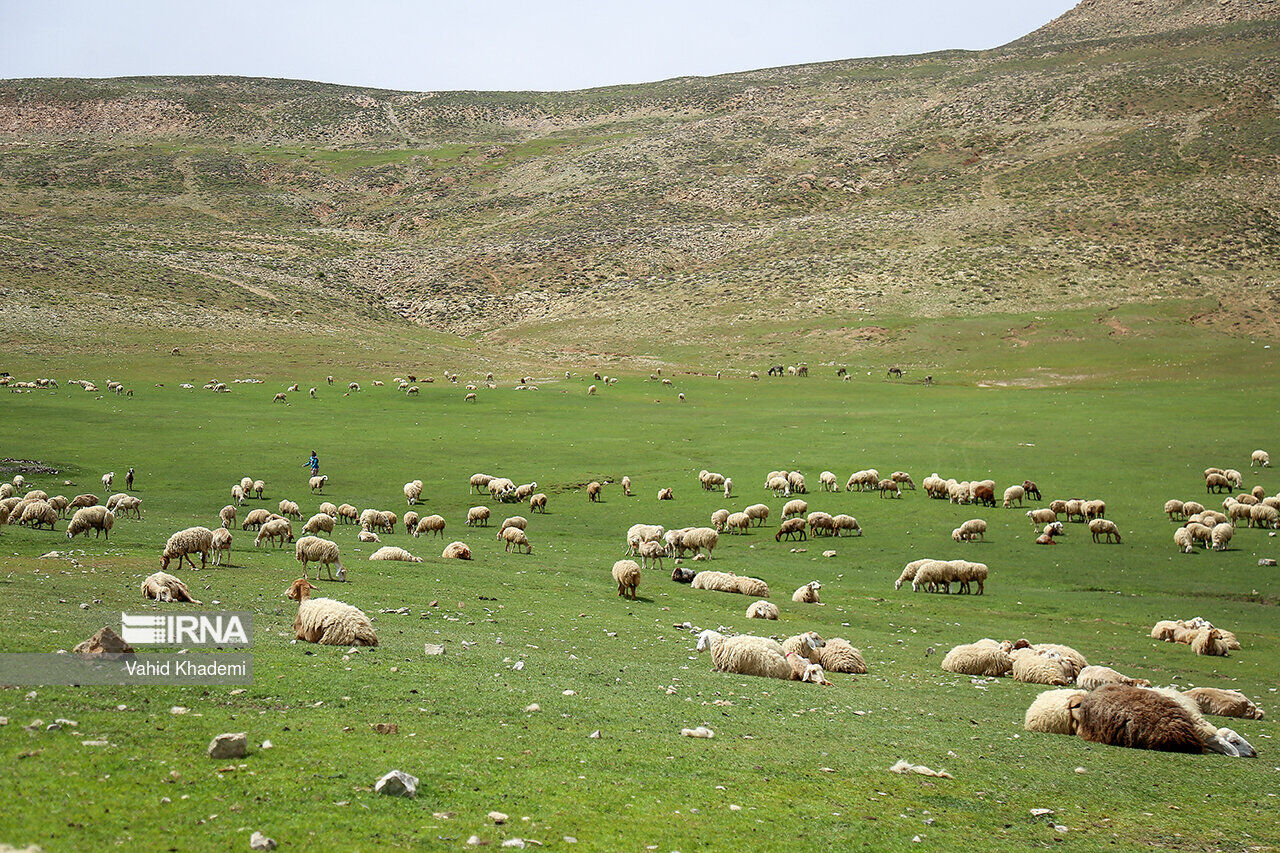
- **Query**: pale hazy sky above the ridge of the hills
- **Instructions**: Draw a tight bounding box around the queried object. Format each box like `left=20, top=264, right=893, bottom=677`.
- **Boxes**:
left=0, top=0, right=1075, bottom=91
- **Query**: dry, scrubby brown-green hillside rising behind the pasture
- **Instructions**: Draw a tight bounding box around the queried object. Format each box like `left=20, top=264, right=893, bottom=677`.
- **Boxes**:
left=0, top=0, right=1280, bottom=357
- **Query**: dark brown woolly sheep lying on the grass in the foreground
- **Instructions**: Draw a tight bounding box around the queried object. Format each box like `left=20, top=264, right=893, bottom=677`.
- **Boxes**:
left=1070, top=684, right=1252, bottom=756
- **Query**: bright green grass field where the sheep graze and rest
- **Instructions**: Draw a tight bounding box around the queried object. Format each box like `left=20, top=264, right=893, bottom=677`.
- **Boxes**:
left=0, top=340, right=1280, bottom=853
